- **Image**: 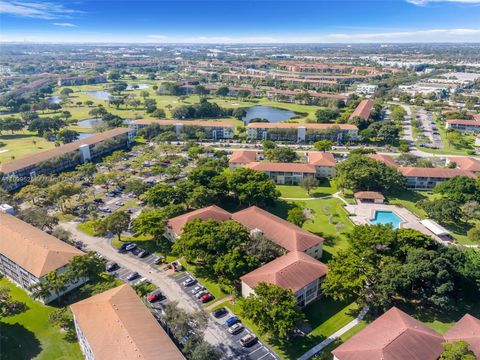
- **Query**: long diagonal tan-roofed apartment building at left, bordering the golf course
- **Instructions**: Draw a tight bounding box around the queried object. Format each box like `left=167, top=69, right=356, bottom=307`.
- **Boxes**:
left=0, top=128, right=134, bottom=191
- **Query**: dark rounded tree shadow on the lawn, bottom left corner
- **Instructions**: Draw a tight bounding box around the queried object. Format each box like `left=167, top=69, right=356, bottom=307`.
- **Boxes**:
left=0, top=322, right=42, bottom=360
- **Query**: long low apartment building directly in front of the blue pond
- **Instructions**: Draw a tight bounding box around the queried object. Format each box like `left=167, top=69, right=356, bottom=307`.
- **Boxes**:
left=247, top=122, right=358, bottom=143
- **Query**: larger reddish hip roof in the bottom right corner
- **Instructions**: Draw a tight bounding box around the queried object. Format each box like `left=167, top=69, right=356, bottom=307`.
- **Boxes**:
left=332, top=307, right=444, bottom=360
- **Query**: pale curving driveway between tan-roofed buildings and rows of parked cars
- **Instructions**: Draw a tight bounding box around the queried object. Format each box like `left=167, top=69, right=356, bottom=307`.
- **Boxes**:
left=59, top=222, right=238, bottom=359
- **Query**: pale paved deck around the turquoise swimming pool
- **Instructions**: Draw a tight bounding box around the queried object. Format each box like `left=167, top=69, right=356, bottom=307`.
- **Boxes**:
left=345, top=203, right=445, bottom=244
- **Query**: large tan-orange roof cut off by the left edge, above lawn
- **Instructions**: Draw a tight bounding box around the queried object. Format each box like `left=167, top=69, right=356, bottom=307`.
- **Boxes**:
left=0, top=212, right=83, bottom=278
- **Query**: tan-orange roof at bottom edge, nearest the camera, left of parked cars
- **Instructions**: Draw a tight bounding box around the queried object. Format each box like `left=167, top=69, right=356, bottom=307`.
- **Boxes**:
left=70, top=284, right=184, bottom=360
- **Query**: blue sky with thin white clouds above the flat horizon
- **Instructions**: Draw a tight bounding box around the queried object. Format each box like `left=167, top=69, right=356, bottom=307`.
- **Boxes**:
left=0, top=0, right=480, bottom=44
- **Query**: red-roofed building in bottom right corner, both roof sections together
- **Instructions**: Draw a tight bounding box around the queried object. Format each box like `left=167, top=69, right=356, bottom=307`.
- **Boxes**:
left=332, top=307, right=480, bottom=360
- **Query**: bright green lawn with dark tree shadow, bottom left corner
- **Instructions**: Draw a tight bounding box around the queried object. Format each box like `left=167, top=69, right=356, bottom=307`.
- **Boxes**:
left=0, top=278, right=83, bottom=360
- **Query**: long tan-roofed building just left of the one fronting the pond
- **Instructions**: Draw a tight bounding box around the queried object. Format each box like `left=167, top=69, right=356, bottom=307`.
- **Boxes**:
left=130, top=119, right=235, bottom=140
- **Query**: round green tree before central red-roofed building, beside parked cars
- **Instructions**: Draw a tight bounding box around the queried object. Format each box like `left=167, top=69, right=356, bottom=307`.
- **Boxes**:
left=240, top=283, right=304, bottom=341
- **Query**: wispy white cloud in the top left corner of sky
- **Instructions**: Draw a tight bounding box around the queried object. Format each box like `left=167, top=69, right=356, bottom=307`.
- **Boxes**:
left=0, top=0, right=82, bottom=20
